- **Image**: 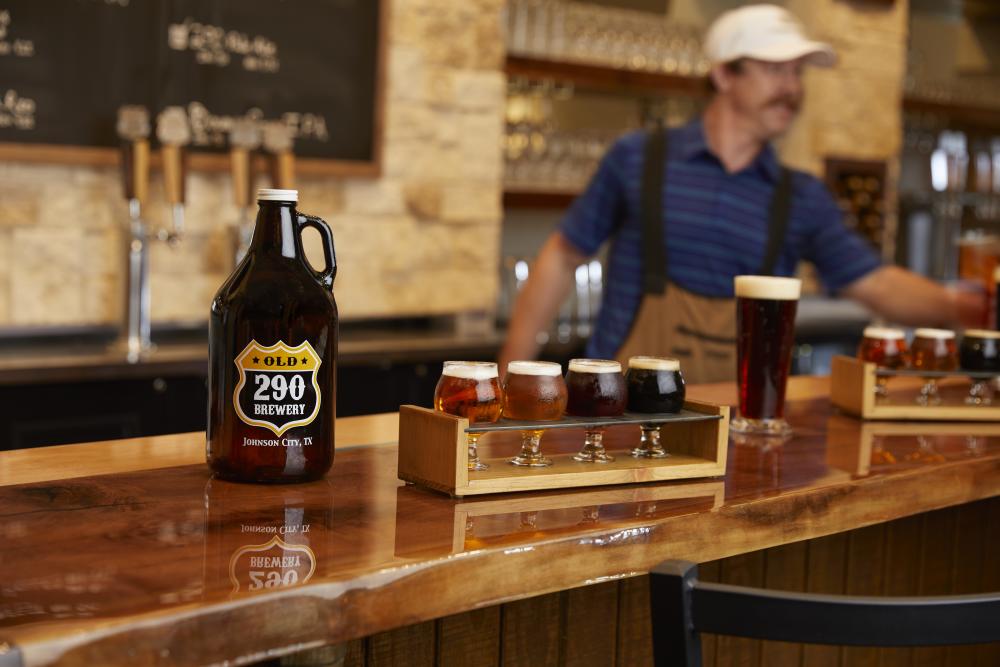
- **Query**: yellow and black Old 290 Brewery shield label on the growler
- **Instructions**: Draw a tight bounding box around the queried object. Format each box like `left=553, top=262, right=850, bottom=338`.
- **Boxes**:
left=233, top=340, right=323, bottom=438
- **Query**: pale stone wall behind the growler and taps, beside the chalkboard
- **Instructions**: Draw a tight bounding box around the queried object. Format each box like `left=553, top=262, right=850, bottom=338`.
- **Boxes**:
left=0, top=0, right=505, bottom=328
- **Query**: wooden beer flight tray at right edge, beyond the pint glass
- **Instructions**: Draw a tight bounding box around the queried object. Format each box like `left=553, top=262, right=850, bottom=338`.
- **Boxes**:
left=830, top=355, right=1000, bottom=422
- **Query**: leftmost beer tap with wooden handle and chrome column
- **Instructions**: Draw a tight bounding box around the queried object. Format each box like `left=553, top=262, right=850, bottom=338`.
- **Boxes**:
left=117, top=105, right=152, bottom=363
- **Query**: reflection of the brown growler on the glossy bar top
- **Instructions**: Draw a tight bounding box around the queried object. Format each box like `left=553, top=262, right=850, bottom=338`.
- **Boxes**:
left=204, top=479, right=333, bottom=597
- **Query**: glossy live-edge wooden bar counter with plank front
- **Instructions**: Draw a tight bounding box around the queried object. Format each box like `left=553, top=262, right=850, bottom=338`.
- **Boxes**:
left=0, top=378, right=1000, bottom=666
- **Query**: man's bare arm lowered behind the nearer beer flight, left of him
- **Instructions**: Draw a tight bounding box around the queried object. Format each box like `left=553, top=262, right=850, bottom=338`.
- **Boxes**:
left=498, top=231, right=587, bottom=376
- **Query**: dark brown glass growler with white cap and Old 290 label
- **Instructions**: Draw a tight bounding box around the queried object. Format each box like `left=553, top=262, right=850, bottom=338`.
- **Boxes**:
left=207, top=190, right=337, bottom=482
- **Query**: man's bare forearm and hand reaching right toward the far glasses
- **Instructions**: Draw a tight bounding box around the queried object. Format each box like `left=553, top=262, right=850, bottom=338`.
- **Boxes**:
left=841, top=266, right=986, bottom=327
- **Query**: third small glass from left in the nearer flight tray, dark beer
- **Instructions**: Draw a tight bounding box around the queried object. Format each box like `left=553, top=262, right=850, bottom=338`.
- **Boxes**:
left=566, top=359, right=625, bottom=463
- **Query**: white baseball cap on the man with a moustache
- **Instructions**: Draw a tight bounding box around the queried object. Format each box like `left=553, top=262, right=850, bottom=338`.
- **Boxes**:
left=704, top=5, right=837, bottom=67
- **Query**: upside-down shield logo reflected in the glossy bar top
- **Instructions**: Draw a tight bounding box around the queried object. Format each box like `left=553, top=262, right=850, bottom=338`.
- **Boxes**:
left=229, top=535, right=316, bottom=593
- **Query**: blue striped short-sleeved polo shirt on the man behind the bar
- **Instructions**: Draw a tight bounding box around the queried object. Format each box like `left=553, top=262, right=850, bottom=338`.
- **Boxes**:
left=559, top=120, right=881, bottom=358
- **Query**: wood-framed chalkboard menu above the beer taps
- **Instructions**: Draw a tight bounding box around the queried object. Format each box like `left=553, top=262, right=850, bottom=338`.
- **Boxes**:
left=0, top=0, right=384, bottom=175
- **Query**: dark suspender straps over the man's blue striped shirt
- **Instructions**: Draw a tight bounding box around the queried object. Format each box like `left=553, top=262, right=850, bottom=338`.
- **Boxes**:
left=640, top=125, right=792, bottom=294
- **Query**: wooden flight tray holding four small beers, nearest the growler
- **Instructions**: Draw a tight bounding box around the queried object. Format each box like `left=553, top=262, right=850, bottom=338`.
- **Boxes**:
left=399, top=400, right=729, bottom=497
